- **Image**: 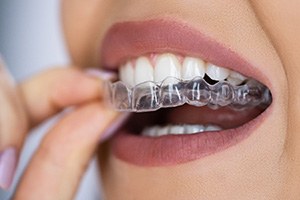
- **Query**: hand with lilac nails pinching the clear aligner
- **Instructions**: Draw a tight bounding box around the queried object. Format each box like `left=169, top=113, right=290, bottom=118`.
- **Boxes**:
left=0, top=55, right=118, bottom=200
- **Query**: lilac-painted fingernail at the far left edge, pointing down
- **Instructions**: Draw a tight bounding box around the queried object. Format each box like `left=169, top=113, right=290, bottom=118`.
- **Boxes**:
left=0, top=147, right=17, bottom=190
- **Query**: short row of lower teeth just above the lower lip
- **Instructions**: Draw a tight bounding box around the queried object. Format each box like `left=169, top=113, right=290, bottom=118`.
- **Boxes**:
left=142, top=124, right=222, bottom=137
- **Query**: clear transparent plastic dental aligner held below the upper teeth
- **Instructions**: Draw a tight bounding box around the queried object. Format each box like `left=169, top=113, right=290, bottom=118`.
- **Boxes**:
left=106, top=77, right=272, bottom=112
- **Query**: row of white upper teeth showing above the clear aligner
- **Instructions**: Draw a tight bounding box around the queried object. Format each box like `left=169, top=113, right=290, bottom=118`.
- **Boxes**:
left=120, top=53, right=246, bottom=87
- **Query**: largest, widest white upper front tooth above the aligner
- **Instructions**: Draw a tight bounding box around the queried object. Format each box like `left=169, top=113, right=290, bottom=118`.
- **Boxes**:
left=154, top=53, right=181, bottom=83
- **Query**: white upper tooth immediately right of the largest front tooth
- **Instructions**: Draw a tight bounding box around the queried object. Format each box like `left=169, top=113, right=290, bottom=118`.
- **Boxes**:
left=181, top=57, right=205, bottom=80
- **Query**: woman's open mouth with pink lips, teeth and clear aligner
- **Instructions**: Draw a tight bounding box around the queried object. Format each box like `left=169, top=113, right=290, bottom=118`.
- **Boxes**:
left=101, top=19, right=272, bottom=166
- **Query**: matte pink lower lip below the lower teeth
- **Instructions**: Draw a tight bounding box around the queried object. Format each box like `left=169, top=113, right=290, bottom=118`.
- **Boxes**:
left=111, top=105, right=272, bottom=166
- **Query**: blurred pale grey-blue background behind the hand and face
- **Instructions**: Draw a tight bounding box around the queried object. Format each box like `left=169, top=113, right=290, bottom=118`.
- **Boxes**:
left=0, top=0, right=100, bottom=200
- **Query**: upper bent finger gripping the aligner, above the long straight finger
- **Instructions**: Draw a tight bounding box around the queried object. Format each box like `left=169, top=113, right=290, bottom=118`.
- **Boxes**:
left=20, top=68, right=103, bottom=125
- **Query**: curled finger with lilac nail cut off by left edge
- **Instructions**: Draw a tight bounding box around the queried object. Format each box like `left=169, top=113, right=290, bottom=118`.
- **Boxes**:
left=0, top=55, right=28, bottom=189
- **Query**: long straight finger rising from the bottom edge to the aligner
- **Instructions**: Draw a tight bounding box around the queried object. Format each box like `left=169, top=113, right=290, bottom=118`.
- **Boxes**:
left=16, top=103, right=117, bottom=200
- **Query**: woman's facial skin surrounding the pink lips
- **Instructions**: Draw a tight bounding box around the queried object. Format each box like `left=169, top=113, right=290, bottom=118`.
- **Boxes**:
left=62, top=0, right=300, bottom=200
